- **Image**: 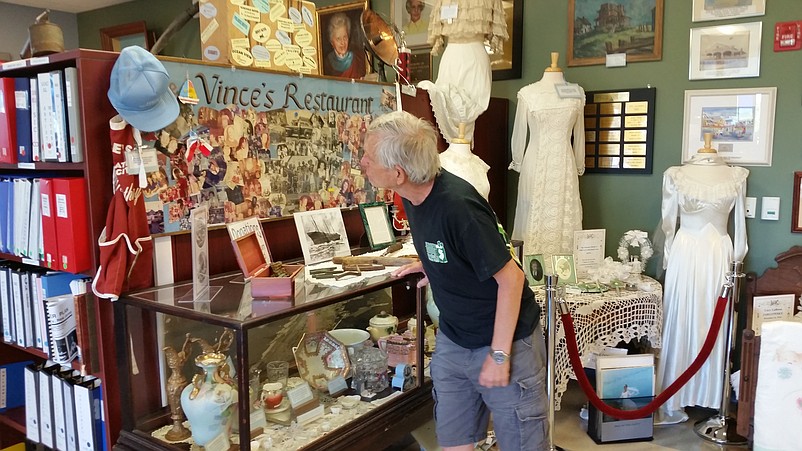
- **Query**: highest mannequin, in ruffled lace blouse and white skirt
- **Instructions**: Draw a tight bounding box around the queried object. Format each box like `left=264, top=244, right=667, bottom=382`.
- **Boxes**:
left=418, top=0, right=508, bottom=142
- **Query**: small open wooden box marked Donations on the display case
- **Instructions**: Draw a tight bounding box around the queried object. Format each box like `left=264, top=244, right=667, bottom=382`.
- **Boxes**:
left=233, top=232, right=304, bottom=299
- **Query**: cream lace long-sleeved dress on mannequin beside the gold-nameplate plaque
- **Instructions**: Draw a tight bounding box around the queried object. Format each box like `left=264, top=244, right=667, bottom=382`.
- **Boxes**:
left=509, top=52, right=585, bottom=261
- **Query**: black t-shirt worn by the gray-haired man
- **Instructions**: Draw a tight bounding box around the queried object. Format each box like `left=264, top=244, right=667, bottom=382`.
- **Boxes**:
left=404, top=170, right=540, bottom=349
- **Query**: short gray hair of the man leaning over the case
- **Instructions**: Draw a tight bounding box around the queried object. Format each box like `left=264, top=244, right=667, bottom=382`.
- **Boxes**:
left=365, top=111, right=440, bottom=184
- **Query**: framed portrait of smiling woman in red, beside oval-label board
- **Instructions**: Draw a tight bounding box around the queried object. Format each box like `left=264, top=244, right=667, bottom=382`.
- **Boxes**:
left=317, top=1, right=369, bottom=79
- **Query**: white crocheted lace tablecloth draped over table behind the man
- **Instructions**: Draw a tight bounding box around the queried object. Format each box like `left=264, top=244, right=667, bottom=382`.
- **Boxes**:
left=532, top=277, right=663, bottom=410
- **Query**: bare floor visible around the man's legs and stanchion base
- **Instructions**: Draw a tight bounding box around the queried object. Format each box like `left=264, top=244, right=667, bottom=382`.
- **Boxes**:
left=386, top=381, right=748, bottom=451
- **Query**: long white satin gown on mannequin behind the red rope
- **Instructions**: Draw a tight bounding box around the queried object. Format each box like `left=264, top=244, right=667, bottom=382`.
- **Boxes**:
left=657, top=133, right=749, bottom=424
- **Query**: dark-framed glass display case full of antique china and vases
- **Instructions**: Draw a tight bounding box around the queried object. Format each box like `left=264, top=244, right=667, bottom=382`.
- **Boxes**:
left=114, top=272, right=433, bottom=451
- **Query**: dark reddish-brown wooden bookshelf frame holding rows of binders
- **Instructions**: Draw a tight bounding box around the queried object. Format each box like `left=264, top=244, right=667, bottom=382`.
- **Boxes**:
left=0, top=49, right=120, bottom=448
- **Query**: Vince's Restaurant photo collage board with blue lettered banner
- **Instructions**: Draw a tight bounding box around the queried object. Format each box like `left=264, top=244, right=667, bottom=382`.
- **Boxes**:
left=142, top=58, right=397, bottom=234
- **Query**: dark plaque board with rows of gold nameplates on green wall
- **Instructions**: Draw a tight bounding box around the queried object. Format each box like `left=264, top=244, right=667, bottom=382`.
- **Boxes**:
left=585, top=88, right=656, bottom=174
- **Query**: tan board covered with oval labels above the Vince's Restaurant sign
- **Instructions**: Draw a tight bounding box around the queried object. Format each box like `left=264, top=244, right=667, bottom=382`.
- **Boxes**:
left=199, top=0, right=320, bottom=75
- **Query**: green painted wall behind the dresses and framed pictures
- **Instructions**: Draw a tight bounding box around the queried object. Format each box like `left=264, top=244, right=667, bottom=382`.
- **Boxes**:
left=78, top=0, right=802, bottom=273
